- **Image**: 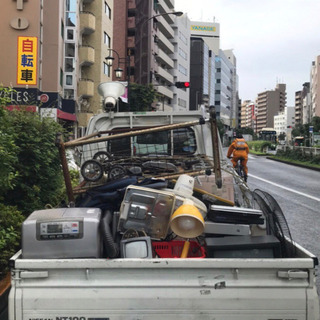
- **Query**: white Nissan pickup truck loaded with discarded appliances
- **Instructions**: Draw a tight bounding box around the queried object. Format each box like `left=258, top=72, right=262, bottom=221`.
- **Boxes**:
left=9, top=112, right=319, bottom=320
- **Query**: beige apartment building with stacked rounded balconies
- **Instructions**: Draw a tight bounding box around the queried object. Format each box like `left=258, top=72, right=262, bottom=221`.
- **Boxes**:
left=78, top=0, right=114, bottom=127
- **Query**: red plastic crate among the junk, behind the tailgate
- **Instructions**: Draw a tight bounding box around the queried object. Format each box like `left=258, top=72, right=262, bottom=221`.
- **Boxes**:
left=152, top=241, right=206, bottom=259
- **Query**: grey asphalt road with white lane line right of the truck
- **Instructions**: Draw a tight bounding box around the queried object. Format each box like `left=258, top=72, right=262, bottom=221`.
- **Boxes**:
left=240, top=155, right=320, bottom=293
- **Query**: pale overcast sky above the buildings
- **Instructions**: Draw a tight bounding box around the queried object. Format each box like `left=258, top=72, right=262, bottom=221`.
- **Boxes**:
left=175, top=0, right=320, bottom=106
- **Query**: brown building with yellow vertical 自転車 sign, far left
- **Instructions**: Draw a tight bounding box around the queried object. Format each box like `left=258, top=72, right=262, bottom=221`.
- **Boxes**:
left=0, top=0, right=76, bottom=127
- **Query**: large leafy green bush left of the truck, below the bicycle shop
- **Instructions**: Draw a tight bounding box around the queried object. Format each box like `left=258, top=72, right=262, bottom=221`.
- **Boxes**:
left=0, top=108, right=63, bottom=216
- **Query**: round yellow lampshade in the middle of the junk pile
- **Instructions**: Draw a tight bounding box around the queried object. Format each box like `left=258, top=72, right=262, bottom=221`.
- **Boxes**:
left=170, top=204, right=204, bottom=239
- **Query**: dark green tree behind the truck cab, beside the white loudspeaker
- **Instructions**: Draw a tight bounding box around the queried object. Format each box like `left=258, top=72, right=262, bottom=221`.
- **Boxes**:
left=119, top=83, right=160, bottom=111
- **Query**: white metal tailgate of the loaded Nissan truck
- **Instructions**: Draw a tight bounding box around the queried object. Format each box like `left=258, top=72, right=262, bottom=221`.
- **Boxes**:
left=9, top=244, right=319, bottom=320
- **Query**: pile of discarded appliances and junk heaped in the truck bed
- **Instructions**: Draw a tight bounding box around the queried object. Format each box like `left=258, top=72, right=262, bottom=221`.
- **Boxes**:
left=18, top=111, right=304, bottom=259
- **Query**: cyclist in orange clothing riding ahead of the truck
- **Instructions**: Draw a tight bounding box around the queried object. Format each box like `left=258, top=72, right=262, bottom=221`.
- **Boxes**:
left=227, top=133, right=249, bottom=182
